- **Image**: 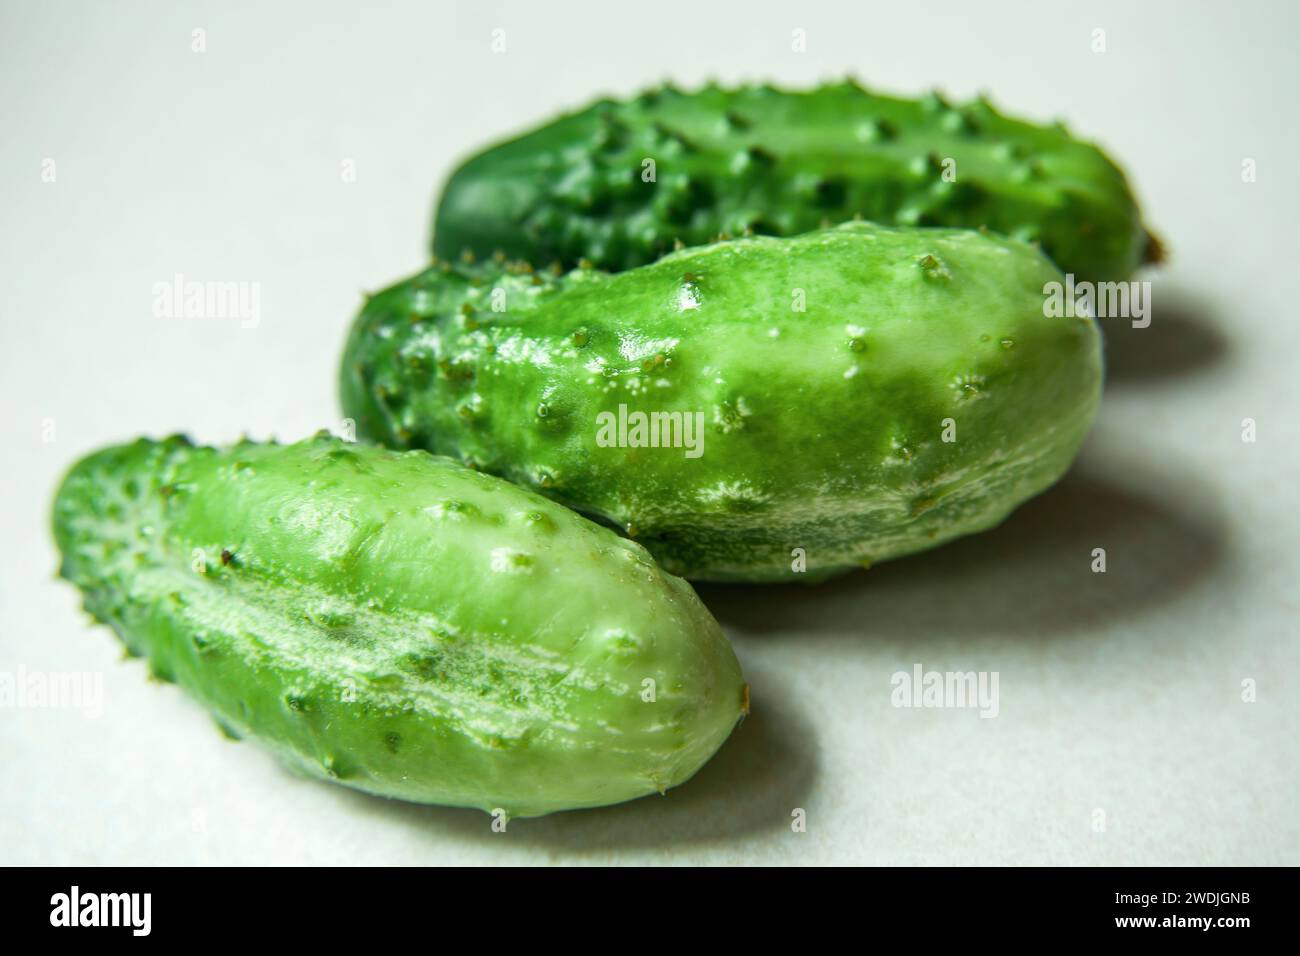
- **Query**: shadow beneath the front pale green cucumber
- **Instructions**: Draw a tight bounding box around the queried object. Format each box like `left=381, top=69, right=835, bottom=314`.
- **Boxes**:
left=346, top=662, right=819, bottom=857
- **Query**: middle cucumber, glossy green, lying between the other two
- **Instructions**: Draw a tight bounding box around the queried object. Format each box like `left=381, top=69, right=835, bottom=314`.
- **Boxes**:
left=341, top=222, right=1102, bottom=581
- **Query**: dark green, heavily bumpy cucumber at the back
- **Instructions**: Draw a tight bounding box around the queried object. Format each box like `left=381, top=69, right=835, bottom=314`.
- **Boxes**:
left=433, top=82, right=1158, bottom=281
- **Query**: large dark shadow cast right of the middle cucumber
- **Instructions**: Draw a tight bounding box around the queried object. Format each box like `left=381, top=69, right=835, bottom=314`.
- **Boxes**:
left=697, top=457, right=1227, bottom=643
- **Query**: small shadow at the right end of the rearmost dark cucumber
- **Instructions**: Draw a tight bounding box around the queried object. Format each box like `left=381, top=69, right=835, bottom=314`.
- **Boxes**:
left=1101, top=281, right=1231, bottom=388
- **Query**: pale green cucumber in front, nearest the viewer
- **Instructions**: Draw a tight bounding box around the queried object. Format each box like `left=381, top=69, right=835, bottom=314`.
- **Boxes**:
left=55, top=436, right=748, bottom=817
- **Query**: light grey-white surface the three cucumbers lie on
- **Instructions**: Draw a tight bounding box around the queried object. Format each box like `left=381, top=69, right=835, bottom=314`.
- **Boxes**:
left=0, top=0, right=1300, bottom=864
